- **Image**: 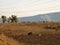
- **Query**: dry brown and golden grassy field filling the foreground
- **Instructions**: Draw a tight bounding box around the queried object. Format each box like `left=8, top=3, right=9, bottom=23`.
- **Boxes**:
left=0, top=22, right=60, bottom=45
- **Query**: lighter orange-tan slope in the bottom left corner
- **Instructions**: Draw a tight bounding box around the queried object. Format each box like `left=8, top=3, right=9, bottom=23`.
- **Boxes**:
left=0, top=33, right=19, bottom=45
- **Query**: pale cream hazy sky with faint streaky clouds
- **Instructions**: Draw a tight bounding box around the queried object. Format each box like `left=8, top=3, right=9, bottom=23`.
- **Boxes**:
left=0, top=0, right=60, bottom=17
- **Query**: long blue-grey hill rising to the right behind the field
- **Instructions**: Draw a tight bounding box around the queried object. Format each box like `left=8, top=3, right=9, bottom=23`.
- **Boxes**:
left=18, top=12, right=60, bottom=22
